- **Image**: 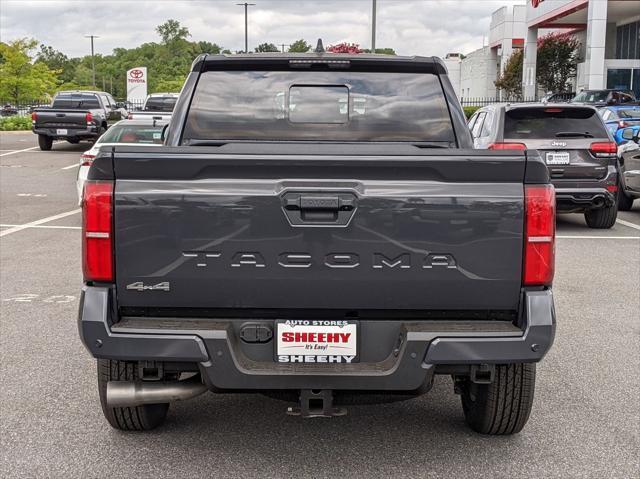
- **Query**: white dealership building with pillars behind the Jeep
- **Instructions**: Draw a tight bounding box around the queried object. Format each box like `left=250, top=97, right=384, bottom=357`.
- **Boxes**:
left=445, top=0, right=640, bottom=99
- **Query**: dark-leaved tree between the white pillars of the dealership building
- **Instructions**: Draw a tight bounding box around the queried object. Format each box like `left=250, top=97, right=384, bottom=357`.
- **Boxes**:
left=536, top=33, right=580, bottom=93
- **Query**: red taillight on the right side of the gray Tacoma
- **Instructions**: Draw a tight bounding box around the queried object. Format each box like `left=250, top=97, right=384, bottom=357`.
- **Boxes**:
left=523, top=185, right=556, bottom=286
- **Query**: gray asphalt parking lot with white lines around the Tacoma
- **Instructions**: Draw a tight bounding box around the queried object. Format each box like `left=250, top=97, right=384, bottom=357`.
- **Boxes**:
left=0, top=132, right=640, bottom=478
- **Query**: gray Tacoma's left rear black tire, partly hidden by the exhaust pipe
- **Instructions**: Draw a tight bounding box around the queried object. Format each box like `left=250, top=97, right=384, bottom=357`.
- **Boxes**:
left=98, top=359, right=169, bottom=431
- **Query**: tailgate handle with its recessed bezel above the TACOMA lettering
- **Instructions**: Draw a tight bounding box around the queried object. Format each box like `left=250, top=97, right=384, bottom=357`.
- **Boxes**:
left=282, top=192, right=356, bottom=226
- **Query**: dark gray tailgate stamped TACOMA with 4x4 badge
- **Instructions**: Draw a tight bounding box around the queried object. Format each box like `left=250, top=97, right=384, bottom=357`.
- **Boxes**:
left=114, top=147, right=526, bottom=310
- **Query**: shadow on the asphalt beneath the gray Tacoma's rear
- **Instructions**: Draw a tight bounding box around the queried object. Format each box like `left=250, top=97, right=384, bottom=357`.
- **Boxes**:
left=114, top=377, right=535, bottom=477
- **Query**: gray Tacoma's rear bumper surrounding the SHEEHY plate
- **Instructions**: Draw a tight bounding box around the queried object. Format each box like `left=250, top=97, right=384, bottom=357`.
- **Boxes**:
left=78, top=286, right=555, bottom=391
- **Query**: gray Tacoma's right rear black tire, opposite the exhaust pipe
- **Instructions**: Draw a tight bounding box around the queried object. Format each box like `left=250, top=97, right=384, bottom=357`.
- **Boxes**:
left=462, top=363, right=536, bottom=435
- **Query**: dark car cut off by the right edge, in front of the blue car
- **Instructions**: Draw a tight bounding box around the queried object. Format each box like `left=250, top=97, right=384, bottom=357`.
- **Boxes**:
left=618, top=128, right=640, bottom=211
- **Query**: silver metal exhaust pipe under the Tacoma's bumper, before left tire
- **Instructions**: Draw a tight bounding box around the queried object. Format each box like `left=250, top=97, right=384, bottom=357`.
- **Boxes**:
left=106, top=376, right=208, bottom=407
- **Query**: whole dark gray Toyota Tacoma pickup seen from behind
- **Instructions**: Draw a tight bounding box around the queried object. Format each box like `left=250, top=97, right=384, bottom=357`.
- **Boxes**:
left=78, top=53, right=555, bottom=434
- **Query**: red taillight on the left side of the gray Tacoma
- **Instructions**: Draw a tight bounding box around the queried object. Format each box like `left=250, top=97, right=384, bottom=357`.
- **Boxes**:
left=82, top=181, right=113, bottom=281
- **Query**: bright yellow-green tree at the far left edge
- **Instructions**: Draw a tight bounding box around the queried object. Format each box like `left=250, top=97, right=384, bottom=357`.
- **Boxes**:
left=0, top=38, right=58, bottom=103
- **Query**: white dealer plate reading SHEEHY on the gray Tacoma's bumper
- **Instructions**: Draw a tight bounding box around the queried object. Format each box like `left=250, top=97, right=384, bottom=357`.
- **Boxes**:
left=273, top=319, right=360, bottom=366
